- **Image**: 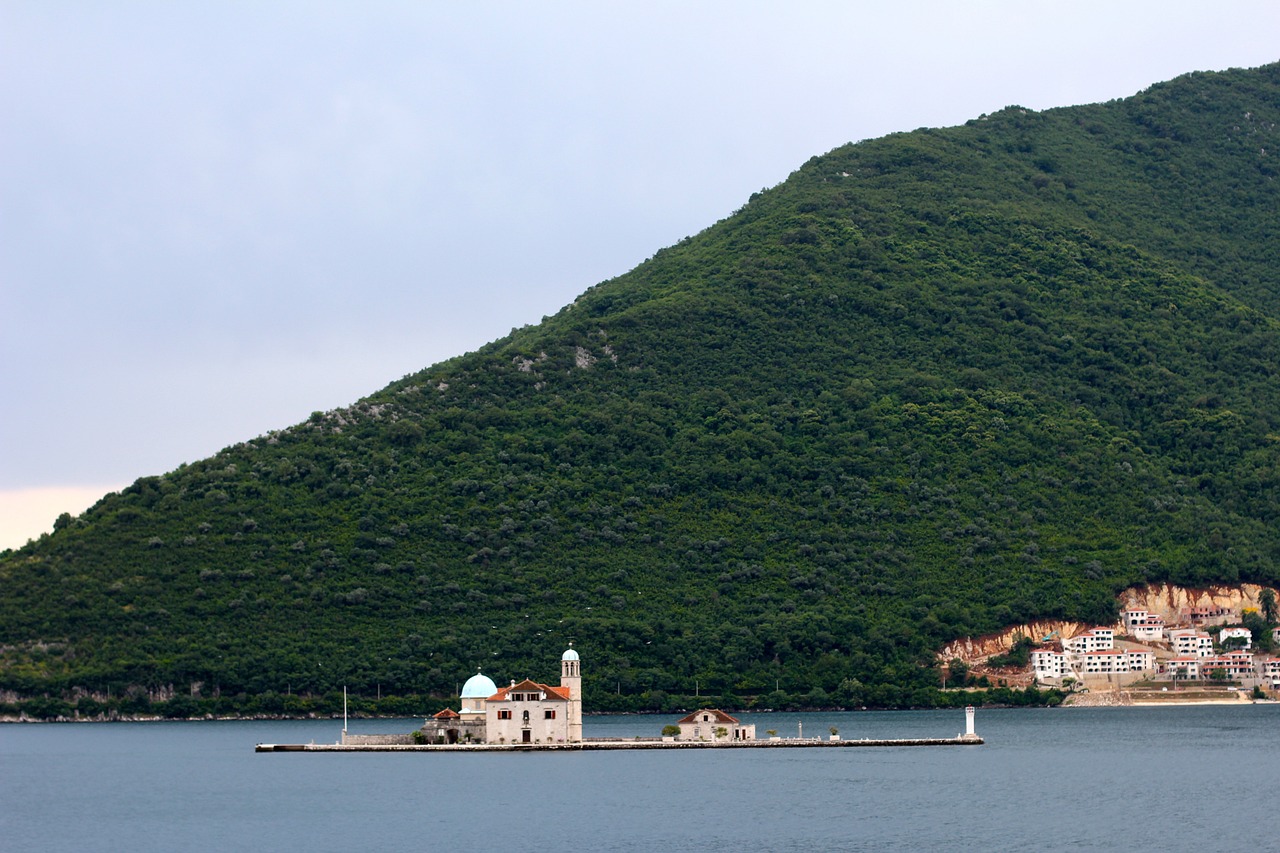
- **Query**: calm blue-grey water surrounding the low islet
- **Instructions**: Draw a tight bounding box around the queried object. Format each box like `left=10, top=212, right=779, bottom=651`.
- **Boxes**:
left=0, top=704, right=1280, bottom=853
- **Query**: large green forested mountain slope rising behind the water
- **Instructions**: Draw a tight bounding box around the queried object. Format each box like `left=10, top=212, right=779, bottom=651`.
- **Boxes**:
left=0, top=65, right=1280, bottom=712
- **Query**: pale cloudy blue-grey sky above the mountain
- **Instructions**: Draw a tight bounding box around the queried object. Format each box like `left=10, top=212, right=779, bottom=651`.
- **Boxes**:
left=0, top=0, right=1280, bottom=548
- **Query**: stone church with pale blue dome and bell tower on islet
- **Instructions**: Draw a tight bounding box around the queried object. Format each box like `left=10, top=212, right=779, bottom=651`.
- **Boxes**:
left=421, top=643, right=582, bottom=744
